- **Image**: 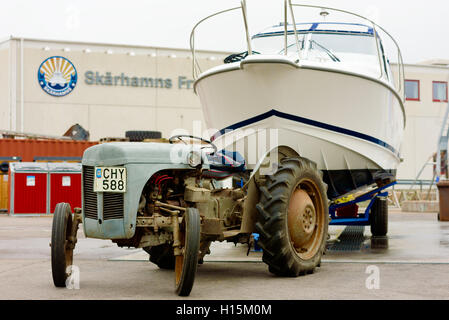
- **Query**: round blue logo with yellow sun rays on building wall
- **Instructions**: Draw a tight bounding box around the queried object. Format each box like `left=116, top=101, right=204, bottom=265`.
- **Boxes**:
left=37, top=56, right=78, bottom=97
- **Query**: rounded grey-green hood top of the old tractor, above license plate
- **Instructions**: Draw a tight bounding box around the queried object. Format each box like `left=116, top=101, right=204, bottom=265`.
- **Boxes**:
left=82, top=142, right=207, bottom=166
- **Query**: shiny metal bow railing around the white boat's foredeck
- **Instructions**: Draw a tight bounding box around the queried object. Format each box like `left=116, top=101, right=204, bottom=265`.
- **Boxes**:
left=190, top=0, right=405, bottom=101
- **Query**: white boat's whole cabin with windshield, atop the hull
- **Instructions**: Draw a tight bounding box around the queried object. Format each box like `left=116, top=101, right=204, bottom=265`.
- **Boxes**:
left=252, top=22, right=393, bottom=81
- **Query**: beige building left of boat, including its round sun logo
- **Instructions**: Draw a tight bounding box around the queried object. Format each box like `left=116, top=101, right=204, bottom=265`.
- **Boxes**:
left=0, top=38, right=227, bottom=140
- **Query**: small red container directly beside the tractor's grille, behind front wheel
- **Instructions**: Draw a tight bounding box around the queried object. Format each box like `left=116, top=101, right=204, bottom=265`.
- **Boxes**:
left=48, top=163, right=81, bottom=213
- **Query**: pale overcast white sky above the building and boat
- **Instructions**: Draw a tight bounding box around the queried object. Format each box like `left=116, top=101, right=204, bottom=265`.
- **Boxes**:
left=0, top=0, right=449, bottom=63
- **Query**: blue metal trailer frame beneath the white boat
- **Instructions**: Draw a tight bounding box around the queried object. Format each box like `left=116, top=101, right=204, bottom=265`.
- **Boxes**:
left=329, top=181, right=397, bottom=226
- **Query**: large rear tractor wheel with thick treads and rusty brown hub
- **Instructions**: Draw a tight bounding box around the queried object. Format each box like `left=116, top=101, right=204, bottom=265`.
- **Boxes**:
left=256, top=158, right=329, bottom=277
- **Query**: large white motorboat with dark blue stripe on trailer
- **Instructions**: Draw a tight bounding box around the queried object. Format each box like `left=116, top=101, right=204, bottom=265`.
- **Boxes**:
left=187, top=1, right=405, bottom=200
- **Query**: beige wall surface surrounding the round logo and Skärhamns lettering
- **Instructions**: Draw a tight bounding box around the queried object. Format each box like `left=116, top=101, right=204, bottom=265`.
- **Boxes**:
left=10, top=40, right=225, bottom=140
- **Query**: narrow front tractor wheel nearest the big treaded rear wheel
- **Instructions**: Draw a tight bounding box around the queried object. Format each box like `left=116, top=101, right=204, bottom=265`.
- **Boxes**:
left=175, top=208, right=200, bottom=296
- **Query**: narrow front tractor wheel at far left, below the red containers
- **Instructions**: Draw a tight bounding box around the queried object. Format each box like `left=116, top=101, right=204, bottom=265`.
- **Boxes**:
left=51, top=202, right=74, bottom=287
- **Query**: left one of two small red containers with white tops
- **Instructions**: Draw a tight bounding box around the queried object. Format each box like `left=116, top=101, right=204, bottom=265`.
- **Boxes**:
left=9, top=162, right=48, bottom=215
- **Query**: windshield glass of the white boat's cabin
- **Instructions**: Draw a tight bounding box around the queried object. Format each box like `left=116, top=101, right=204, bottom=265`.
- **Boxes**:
left=253, top=33, right=377, bottom=63
